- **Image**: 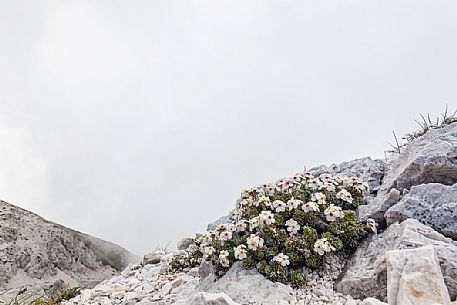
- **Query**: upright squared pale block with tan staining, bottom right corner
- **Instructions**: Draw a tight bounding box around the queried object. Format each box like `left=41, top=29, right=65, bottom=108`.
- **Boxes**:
left=386, top=245, right=451, bottom=305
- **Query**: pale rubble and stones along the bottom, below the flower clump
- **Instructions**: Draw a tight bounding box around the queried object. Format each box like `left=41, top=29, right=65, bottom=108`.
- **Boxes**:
left=63, top=250, right=360, bottom=305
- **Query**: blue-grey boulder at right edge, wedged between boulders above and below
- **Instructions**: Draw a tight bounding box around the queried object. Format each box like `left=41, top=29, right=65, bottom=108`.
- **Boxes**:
left=385, top=183, right=457, bottom=239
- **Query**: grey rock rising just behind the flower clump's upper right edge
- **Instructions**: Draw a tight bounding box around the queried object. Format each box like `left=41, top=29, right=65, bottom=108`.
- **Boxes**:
left=310, top=157, right=385, bottom=191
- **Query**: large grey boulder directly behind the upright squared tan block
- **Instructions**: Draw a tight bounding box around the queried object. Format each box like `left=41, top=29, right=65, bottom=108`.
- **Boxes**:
left=335, top=219, right=457, bottom=301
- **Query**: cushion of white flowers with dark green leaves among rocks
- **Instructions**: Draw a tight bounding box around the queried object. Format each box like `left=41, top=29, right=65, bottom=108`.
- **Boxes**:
left=192, top=172, right=377, bottom=286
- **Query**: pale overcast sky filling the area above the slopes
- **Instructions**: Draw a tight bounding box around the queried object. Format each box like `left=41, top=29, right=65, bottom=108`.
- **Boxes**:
left=0, top=0, right=457, bottom=254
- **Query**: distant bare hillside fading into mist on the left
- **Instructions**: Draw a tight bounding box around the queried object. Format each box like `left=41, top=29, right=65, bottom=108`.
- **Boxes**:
left=0, top=201, right=138, bottom=300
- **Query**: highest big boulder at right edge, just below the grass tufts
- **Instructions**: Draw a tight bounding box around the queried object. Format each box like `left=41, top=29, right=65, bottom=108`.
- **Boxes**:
left=383, top=123, right=457, bottom=191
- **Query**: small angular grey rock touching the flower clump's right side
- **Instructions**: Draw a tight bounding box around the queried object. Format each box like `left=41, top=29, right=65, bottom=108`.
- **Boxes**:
left=358, top=188, right=400, bottom=227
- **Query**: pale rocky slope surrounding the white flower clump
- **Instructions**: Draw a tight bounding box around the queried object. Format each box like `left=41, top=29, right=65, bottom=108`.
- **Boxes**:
left=8, top=123, right=457, bottom=305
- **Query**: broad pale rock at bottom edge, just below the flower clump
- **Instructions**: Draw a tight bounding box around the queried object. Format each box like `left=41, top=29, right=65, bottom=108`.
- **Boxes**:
left=198, top=262, right=293, bottom=305
